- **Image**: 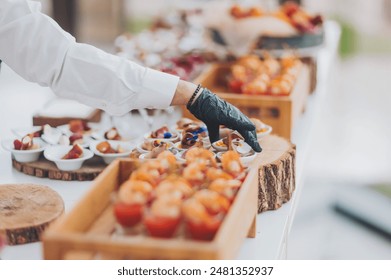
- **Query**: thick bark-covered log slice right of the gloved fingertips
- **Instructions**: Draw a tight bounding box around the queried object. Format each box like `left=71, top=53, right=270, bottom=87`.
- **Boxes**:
left=256, top=135, right=296, bottom=213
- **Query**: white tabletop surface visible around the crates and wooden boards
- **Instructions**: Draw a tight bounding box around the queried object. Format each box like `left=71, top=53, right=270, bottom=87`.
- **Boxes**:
left=0, top=22, right=340, bottom=260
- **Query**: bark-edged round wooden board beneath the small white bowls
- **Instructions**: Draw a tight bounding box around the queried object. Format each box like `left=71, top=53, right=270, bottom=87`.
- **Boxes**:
left=12, top=156, right=107, bottom=181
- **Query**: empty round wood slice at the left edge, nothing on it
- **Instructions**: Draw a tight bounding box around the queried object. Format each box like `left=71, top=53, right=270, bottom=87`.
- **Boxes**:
left=0, top=184, right=64, bottom=245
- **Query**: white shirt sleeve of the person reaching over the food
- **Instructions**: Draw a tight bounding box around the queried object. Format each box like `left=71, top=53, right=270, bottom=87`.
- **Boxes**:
left=0, top=0, right=179, bottom=115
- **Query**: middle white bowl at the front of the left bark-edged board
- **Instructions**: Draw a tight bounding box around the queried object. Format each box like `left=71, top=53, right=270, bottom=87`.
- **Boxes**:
left=43, top=146, right=94, bottom=171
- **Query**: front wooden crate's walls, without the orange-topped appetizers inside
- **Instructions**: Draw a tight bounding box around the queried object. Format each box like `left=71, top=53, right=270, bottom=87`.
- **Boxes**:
left=43, top=159, right=258, bottom=259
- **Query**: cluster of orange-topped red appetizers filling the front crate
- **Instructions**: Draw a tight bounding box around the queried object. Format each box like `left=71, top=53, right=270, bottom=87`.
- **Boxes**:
left=114, top=148, right=247, bottom=241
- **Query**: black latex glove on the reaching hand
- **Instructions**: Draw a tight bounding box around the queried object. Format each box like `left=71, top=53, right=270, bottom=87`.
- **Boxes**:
left=187, top=88, right=262, bottom=152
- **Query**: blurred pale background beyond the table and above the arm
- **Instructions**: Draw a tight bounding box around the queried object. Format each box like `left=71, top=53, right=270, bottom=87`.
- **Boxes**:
left=33, top=0, right=391, bottom=259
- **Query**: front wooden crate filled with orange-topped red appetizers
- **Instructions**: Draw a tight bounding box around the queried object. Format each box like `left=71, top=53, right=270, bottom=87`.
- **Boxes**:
left=43, top=148, right=258, bottom=259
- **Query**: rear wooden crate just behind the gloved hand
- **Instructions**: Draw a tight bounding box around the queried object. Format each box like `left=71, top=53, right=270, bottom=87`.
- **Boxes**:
left=182, top=63, right=310, bottom=139
